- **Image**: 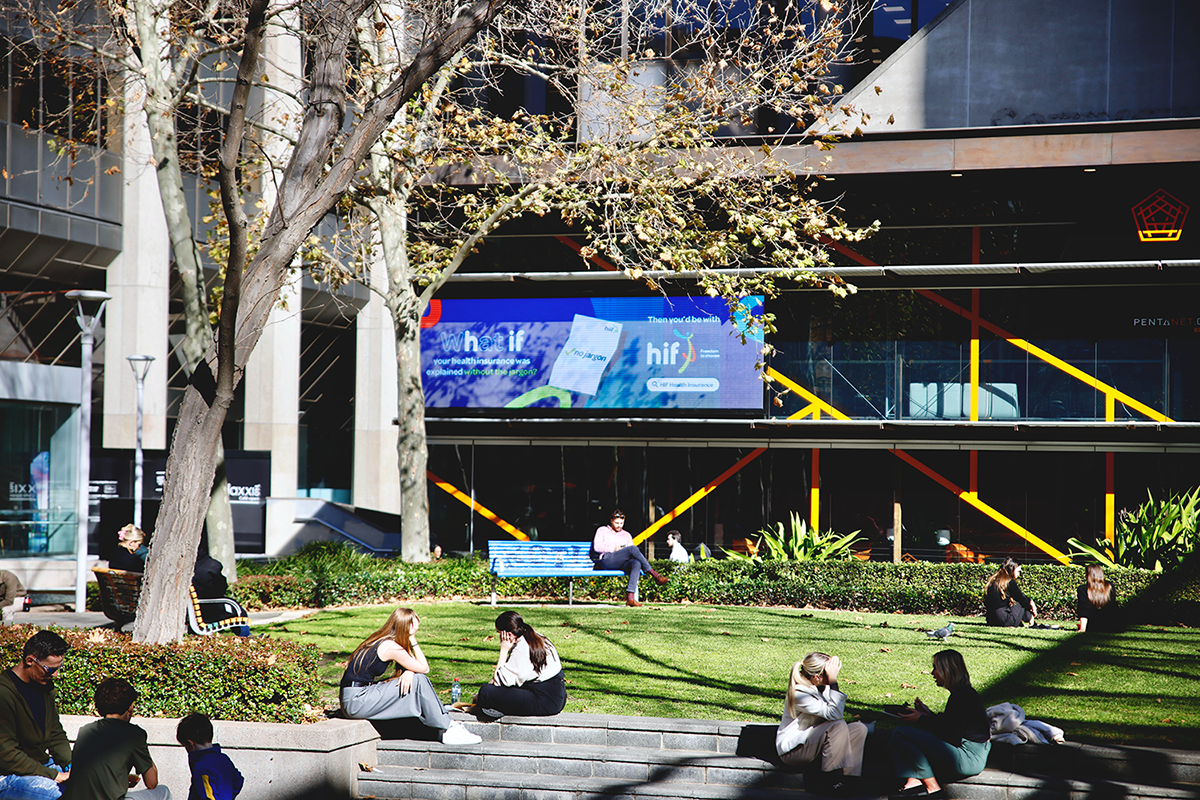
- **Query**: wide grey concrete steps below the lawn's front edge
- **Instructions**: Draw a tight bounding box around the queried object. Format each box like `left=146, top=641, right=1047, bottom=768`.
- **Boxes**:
left=359, top=712, right=1200, bottom=800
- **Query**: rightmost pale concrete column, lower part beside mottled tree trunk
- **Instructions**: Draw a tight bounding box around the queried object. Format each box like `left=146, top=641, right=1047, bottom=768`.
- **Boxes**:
left=353, top=264, right=400, bottom=515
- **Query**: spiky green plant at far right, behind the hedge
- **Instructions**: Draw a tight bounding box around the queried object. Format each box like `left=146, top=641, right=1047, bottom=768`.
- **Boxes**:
left=1067, top=486, right=1200, bottom=572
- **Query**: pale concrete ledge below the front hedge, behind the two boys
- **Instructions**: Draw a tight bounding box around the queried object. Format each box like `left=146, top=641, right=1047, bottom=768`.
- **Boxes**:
left=62, top=715, right=379, bottom=800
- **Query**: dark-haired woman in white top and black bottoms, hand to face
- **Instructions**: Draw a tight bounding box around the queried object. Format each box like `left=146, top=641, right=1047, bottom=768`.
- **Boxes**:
left=475, top=612, right=566, bottom=720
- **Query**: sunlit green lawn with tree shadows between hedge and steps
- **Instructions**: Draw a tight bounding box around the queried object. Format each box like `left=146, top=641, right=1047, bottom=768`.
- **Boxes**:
left=266, top=602, right=1200, bottom=748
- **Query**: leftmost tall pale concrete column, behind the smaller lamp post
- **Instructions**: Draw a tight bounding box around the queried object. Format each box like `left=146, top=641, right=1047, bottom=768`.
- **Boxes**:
left=101, top=88, right=172, bottom=450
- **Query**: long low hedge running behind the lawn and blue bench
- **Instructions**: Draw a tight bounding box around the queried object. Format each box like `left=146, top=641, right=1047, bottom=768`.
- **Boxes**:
left=232, top=558, right=1200, bottom=625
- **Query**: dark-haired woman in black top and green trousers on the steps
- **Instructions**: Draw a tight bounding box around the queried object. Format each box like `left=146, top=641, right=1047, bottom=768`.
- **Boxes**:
left=888, top=650, right=991, bottom=800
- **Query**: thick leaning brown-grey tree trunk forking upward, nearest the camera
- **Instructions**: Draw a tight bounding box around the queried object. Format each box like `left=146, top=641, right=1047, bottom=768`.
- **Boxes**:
left=133, top=0, right=505, bottom=643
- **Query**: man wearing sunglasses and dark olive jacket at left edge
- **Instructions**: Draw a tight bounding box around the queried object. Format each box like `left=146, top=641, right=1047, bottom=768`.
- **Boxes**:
left=0, top=631, right=71, bottom=800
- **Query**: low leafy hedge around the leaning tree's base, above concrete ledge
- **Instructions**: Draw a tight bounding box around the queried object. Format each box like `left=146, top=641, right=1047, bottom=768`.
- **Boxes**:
left=0, top=625, right=323, bottom=722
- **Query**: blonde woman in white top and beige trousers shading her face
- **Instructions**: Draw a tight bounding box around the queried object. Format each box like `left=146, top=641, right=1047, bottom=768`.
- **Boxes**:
left=775, top=652, right=869, bottom=795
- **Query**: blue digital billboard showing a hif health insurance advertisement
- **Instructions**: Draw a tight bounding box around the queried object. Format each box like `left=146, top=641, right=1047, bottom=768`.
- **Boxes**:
left=421, top=296, right=763, bottom=411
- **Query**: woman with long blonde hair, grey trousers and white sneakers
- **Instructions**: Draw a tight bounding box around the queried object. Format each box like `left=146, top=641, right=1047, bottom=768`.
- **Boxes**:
left=342, top=608, right=481, bottom=745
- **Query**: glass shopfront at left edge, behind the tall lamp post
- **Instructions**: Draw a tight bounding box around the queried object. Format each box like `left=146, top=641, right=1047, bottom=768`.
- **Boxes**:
left=0, top=402, right=79, bottom=558
